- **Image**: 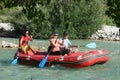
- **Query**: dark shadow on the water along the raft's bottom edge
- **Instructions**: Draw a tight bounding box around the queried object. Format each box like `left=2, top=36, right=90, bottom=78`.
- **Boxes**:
left=19, top=63, right=106, bottom=71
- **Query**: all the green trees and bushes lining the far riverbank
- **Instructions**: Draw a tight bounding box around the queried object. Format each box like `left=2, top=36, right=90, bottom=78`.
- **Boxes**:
left=0, top=0, right=116, bottom=39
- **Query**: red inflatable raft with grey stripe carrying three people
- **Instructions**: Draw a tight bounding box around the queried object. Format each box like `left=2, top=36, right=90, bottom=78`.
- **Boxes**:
left=15, top=50, right=109, bottom=68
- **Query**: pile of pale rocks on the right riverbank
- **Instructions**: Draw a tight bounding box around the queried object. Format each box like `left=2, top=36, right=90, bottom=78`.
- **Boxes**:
left=90, top=25, right=120, bottom=41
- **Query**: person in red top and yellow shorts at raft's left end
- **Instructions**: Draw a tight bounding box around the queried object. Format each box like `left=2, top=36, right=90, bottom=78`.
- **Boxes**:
left=19, top=31, right=34, bottom=54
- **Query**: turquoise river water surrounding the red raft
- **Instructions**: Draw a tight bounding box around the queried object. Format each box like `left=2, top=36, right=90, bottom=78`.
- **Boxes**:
left=0, top=38, right=120, bottom=80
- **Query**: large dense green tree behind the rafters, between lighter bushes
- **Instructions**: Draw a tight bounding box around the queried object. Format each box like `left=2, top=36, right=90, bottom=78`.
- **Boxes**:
left=20, top=0, right=105, bottom=39
